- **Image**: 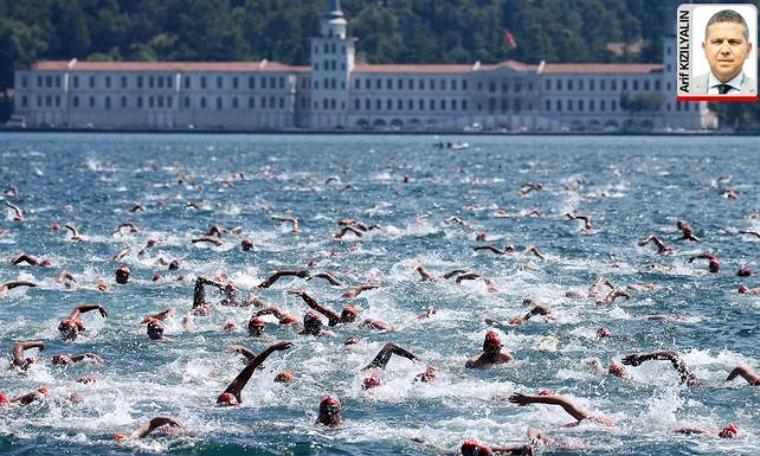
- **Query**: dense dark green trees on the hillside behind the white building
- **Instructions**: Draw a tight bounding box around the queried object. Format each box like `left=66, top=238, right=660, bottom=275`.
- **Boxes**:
left=0, top=0, right=760, bottom=126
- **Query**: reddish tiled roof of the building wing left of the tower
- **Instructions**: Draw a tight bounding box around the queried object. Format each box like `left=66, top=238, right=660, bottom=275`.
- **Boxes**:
left=32, top=60, right=311, bottom=73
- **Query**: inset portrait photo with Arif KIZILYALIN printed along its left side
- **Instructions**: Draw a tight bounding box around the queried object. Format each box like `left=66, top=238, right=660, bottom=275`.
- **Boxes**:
left=676, top=4, right=758, bottom=101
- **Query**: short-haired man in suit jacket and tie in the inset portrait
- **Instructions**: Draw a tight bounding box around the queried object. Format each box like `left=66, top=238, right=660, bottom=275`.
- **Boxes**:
left=692, top=9, right=757, bottom=95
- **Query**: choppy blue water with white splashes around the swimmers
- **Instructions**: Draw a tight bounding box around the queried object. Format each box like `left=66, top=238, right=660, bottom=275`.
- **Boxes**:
left=0, top=134, right=760, bottom=455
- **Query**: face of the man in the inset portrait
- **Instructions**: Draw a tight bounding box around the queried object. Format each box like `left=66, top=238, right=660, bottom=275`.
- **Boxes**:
left=702, top=22, right=752, bottom=83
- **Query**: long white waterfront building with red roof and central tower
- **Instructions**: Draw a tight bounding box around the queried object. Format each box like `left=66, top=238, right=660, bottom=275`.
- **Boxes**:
left=15, top=0, right=716, bottom=131
